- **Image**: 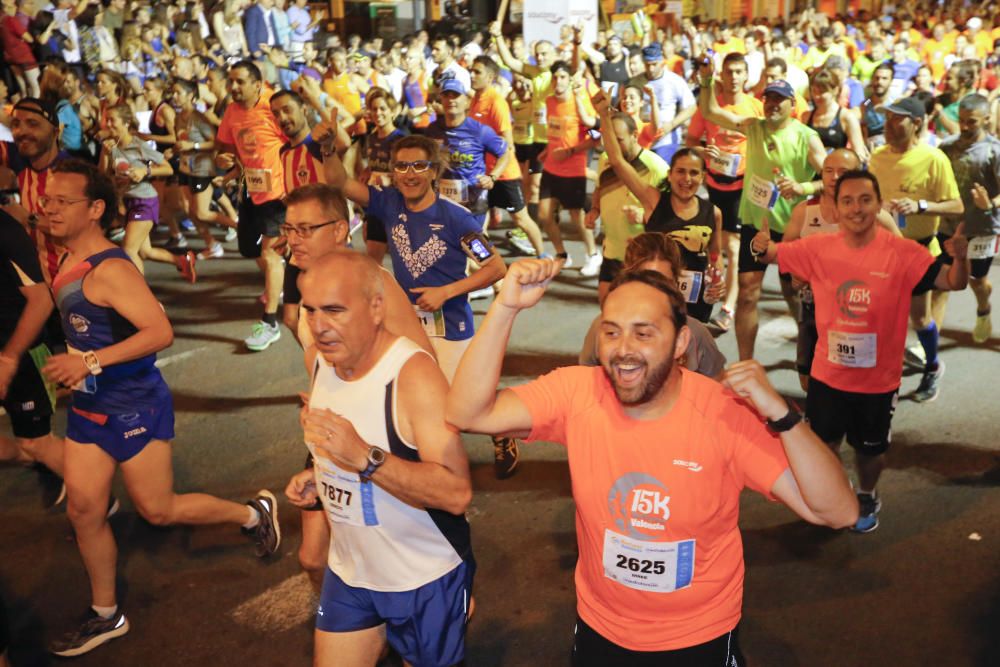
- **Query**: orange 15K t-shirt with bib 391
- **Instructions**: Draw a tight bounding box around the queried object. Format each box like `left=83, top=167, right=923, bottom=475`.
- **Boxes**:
left=778, top=227, right=934, bottom=394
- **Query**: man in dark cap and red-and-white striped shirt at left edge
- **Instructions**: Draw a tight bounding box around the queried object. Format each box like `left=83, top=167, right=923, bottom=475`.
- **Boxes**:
left=0, top=97, right=69, bottom=284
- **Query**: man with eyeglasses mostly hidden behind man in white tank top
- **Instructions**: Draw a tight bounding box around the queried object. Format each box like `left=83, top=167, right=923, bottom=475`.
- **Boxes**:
left=281, top=183, right=433, bottom=592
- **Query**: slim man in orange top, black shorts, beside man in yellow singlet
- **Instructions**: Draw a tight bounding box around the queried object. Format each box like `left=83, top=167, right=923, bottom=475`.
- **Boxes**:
left=538, top=60, right=601, bottom=277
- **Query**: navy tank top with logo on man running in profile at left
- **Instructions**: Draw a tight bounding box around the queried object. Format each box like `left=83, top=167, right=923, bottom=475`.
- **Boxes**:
left=52, top=248, right=170, bottom=415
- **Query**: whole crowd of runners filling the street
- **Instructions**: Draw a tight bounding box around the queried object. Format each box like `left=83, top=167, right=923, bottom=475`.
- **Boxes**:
left=0, top=0, right=1000, bottom=666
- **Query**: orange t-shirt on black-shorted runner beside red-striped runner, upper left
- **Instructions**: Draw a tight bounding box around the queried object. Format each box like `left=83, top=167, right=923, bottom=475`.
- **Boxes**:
left=216, top=90, right=288, bottom=204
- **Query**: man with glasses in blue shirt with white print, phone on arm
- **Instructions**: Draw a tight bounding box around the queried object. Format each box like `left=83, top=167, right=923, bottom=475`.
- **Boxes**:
left=323, top=135, right=507, bottom=381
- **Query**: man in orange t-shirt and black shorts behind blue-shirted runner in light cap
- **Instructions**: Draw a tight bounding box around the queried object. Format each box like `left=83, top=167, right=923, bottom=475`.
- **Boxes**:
left=469, top=56, right=544, bottom=255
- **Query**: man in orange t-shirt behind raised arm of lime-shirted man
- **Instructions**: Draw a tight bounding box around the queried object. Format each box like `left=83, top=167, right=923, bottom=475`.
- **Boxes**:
left=687, top=53, right=764, bottom=331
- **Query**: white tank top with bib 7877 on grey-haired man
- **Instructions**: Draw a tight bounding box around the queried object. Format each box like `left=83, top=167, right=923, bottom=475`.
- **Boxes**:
left=306, top=337, right=472, bottom=592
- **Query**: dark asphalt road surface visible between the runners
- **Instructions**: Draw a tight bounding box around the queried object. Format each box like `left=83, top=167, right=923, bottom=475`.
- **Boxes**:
left=0, top=227, right=1000, bottom=667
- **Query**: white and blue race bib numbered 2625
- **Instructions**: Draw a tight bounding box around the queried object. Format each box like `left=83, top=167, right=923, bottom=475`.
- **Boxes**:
left=604, top=529, right=695, bottom=593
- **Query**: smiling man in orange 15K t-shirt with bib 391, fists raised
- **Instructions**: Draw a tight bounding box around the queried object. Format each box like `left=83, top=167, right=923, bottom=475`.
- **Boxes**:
left=751, top=170, right=969, bottom=533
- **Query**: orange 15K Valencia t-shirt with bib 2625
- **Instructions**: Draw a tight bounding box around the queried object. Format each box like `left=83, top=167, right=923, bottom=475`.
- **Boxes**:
left=512, top=366, right=788, bottom=651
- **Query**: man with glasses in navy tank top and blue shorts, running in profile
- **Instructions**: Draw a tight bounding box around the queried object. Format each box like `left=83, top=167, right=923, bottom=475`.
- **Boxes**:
left=42, top=160, right=281, bottom=657
